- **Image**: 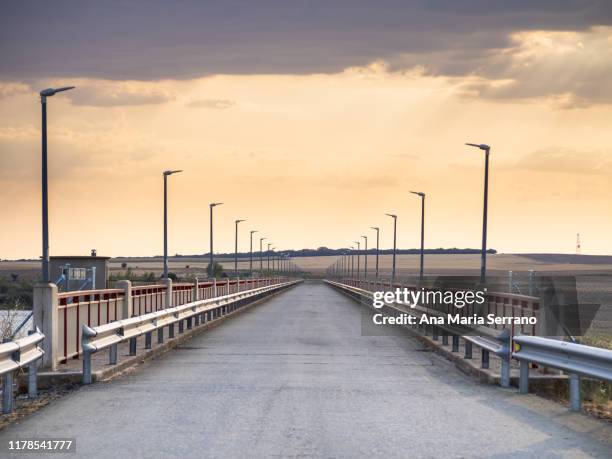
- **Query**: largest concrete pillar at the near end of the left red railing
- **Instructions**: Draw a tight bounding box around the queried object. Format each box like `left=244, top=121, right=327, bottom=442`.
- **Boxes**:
left=33, top=282, right=60, bottom=371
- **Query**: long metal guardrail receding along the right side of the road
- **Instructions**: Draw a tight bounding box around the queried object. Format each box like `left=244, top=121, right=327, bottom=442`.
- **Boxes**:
left=325, top=280, right=512, bottom=387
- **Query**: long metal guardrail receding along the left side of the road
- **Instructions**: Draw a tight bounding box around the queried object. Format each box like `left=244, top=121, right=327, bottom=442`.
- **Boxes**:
left=82, top=281, right=299, bottom=384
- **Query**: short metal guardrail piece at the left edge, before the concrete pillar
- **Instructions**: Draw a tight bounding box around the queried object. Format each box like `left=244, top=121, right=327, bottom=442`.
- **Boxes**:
left=0, top=329, right=45, bottom=414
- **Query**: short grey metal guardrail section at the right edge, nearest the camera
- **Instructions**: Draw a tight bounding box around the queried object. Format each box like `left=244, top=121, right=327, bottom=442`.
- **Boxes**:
left=512, top=336, right=612, bottom=411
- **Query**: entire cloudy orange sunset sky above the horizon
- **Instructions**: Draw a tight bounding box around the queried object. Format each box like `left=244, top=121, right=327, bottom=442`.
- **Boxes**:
left=0, top=0, right=612, bottom=259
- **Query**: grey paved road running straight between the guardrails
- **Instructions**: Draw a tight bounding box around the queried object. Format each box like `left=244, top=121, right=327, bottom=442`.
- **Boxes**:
left=0, top=283, right=612, bottom=458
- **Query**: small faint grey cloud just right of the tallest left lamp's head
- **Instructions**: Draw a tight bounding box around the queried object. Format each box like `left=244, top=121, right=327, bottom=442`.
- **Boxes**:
left=66, top=81, right=175, bottom=107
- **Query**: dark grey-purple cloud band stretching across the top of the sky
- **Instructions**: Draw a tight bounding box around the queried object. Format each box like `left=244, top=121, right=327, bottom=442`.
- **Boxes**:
left=0, top=0, right=612, bottom=106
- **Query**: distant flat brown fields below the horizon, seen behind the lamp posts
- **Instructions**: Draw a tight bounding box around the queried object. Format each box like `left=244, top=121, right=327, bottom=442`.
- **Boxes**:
left=0, top=254, right=612, bottom=336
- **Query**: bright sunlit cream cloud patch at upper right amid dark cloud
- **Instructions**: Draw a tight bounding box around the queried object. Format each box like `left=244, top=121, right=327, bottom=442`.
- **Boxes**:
left=464, top=27, right=612, bottom=108
